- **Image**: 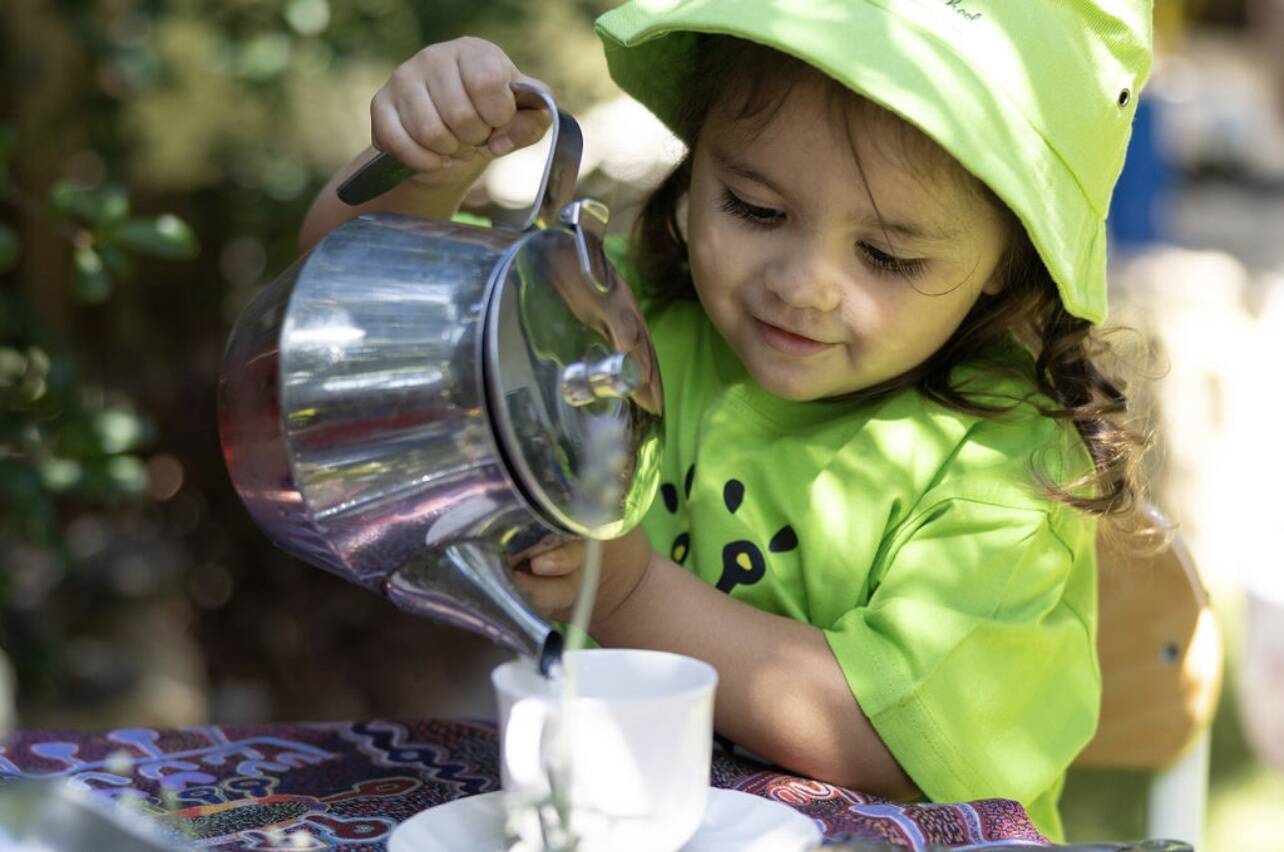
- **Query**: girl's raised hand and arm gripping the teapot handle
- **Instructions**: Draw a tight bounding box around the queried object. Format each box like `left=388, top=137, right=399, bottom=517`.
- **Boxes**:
left=299, top=37, right=551, bottom=251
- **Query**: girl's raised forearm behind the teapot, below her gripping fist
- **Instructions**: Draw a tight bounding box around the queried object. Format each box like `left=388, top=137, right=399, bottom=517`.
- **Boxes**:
left=299, top=148, right=488, bottom=253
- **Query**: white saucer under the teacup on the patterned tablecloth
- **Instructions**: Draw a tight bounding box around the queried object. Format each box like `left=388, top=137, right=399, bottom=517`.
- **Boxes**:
left=388, top=788, right=820, bottom=852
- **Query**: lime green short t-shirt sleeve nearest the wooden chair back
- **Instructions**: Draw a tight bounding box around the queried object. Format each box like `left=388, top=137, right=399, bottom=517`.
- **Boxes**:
left=826, top=497, right=1100, bottom=835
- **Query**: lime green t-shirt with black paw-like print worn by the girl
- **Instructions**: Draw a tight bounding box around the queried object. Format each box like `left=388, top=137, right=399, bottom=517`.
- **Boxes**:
left=609, top=234, right=1102, bottom=839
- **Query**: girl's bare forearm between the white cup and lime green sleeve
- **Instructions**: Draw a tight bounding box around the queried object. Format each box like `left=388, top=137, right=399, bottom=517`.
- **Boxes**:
left=592, top=554, right=917, bottom=799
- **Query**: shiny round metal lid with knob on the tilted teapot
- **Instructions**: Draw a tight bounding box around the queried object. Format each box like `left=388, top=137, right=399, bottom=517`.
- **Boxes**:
left=483, top=209, right=664, bottom=539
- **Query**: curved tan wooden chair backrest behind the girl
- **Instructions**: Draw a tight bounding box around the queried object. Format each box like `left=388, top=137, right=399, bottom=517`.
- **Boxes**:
left=1075, top=508, right=1222, bottom=770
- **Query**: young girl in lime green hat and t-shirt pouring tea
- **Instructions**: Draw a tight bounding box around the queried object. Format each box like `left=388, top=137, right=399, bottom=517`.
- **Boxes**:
left=302, top=0, right=1150, bottom=838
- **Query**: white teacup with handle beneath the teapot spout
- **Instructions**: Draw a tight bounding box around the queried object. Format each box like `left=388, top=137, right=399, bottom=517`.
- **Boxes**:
left=490, top=648, right=718, bottom=852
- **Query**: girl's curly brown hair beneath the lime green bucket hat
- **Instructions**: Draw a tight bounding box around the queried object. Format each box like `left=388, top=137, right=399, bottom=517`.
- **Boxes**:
left=633, top=36, right=1149, bottom=521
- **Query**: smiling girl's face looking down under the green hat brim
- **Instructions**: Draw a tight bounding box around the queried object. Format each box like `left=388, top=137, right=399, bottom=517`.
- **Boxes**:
left=688, top=81, right=1007, bottom=400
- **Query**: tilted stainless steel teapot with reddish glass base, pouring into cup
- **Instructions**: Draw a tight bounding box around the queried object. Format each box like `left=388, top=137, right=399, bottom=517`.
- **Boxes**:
left=218, top=83, right=663, bottom=669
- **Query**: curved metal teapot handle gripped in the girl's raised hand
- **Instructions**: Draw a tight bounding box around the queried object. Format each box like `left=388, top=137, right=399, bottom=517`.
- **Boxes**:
left=338, top=82, right=584, bottom=231
